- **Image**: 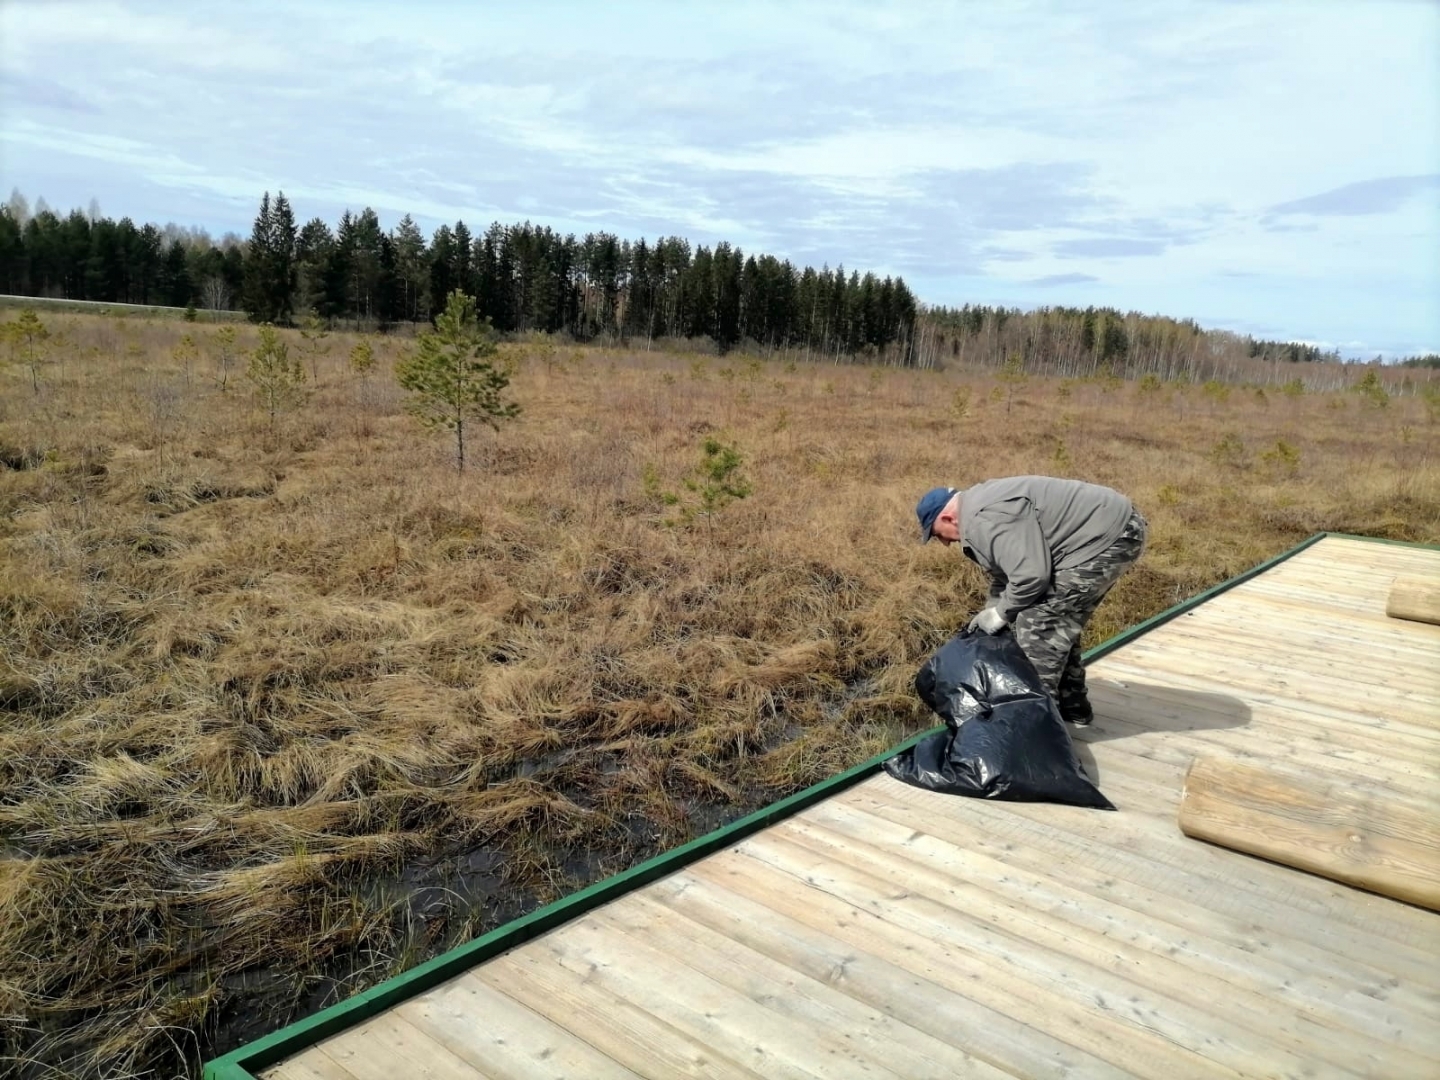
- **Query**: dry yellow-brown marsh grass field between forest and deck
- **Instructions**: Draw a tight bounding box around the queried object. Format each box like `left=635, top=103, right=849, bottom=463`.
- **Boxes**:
left=0, top=317, right=1440, bottom=1077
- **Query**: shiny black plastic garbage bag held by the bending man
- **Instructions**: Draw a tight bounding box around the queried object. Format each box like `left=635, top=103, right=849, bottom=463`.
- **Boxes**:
left=884, top=631, right=1115, bottom=809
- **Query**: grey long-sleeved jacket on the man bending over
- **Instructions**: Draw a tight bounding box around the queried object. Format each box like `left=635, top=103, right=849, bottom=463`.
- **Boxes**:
left=960, top=477, right=1135, bottom=621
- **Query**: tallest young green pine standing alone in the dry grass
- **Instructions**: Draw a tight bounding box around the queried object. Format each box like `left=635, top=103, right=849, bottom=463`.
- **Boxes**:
left=395, top=289, right=520, bottom=471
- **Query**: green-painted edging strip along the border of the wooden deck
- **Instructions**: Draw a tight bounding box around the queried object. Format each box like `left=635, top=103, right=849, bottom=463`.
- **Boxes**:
left=202, top=533, right=1440, bottom=1080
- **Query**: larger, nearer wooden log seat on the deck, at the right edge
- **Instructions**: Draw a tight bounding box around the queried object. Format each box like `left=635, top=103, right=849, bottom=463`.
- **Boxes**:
left=1179, top=757, right=1440, bottom=910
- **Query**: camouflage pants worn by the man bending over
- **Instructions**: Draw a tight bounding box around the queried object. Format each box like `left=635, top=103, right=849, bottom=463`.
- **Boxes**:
left=1015, top=510, right=1146, bottom=720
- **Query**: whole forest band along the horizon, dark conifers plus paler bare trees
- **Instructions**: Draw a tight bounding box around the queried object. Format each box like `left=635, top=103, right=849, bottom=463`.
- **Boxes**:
left=0, top=192, right=1440, bottom=379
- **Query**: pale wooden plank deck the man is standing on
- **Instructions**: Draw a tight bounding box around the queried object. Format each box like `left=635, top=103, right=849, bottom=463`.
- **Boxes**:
left=264, top=537, right=1440, bottom=1080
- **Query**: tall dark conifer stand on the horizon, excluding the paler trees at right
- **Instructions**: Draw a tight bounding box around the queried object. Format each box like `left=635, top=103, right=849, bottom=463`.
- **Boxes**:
left=0, top=193, right=919, bottom=363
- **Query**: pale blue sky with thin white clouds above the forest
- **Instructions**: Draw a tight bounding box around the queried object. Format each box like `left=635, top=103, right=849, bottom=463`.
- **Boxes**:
left=0, top=0, right=1440, bottom=357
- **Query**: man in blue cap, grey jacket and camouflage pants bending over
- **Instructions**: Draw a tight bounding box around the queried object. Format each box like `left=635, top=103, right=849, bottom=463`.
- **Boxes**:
left=914, top=477, right=1146, bottom=727
